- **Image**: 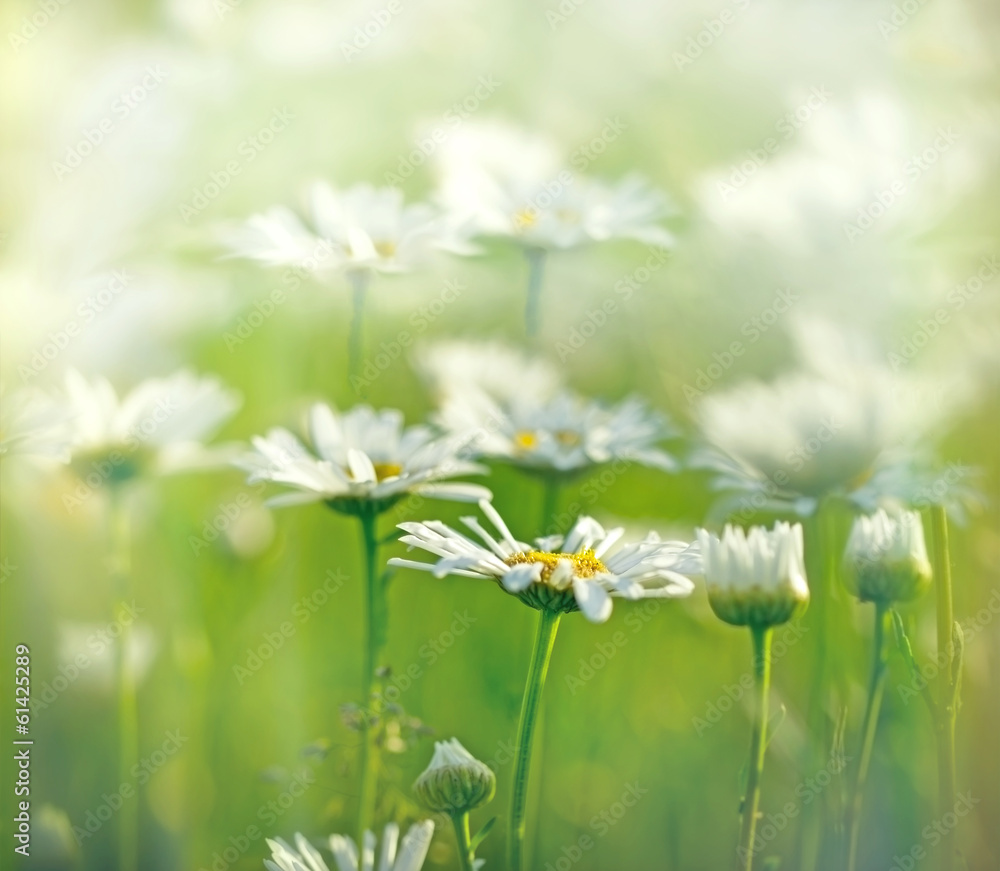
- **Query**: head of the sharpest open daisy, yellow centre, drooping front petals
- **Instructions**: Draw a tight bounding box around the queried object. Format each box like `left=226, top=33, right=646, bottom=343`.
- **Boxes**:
left=389, top=502, right=701, bottom=623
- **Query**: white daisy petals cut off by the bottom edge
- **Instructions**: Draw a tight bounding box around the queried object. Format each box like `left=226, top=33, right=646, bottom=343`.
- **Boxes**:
left=264, top=820, right=434, bottom=871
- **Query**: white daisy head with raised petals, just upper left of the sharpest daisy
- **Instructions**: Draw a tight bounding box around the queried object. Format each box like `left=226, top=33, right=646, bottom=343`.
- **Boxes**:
left=236, top=403, right=492, bottom=513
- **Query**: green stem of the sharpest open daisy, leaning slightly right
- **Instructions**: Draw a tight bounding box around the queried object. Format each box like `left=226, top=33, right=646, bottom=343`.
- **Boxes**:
left=507, top=611, right=562, bottom=871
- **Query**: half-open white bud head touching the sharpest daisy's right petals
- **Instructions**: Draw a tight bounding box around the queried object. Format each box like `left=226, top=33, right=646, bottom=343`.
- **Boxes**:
left=698, top=523, right=809, bottom=628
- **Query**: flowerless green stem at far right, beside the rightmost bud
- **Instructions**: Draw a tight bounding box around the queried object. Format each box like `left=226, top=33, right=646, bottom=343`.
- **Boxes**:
left=931, top=505, right=958, bottom=871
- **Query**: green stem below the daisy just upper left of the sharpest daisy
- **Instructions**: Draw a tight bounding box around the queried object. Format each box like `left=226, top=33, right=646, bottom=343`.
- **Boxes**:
left=357, top=509, right=384, bottom=846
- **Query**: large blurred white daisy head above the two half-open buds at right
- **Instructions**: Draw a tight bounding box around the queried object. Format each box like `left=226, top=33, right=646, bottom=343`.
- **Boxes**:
left=692, top=321, right=959, bottom=515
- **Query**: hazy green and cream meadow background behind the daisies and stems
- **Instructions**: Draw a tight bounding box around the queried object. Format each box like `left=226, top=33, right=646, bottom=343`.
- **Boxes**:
left=0, top=0, right=1000, bottom=871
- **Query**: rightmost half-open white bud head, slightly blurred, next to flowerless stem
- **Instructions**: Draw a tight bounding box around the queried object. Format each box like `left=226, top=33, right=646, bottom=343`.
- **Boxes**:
left=844, top=508, right=931, bottom=604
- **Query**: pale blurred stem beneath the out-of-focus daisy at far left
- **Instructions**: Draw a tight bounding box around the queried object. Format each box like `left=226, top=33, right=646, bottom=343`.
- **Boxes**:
left=109, top=484, right=139, bottom=871
